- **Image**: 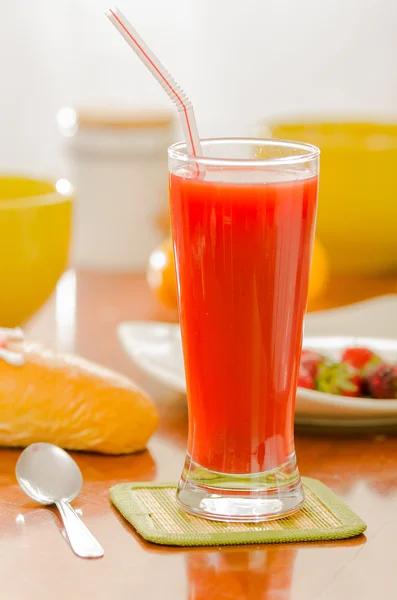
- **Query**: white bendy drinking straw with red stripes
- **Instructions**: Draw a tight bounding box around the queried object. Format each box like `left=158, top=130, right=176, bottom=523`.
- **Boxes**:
left=106, top=8, right=201, bottom=156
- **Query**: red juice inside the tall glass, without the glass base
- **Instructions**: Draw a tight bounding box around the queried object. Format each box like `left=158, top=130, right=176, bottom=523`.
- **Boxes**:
left=170, top=172, right=317, bottom=474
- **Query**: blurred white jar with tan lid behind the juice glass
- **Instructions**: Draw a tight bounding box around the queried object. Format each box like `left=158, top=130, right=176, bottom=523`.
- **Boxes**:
left=57, top=108, right=173, bottom=271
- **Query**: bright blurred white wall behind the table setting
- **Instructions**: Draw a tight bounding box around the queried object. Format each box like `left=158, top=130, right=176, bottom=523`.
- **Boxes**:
left=0, top=0, right=397, bottom=176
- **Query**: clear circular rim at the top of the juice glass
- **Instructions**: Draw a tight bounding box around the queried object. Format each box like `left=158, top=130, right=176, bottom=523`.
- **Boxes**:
left=168, top=137, right=320, bottom=167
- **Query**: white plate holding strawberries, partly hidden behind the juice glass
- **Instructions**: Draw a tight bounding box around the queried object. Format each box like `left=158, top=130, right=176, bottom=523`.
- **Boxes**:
left=118, top=295, right=397, bottom=427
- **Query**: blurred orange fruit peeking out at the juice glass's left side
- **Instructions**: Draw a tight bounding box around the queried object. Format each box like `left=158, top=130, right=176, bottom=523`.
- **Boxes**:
left=146, top=238, right=178, bottom=309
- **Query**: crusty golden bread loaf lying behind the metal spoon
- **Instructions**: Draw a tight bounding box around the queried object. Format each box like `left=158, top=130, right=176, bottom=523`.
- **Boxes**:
left=0, top=342, right=158, bottom=454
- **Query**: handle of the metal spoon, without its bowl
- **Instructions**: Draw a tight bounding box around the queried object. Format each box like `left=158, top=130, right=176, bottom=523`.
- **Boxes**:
left=56, top=500, right=104, bottom=558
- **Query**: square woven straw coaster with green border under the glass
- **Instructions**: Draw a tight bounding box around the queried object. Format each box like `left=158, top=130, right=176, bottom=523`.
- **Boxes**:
left=110, top=477, right=367, bottom=546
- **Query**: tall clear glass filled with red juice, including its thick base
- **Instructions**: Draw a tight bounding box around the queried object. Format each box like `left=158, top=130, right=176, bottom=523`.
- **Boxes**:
left=169, top=138, right=319, bottom=521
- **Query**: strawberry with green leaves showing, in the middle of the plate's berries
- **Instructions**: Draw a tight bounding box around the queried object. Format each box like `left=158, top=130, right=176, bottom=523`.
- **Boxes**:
left=315, top=363, right=363, bottom=398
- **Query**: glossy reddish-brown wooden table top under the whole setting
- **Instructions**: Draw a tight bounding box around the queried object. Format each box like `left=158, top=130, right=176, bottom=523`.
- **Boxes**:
left=0, top=273, right=397, bottom=600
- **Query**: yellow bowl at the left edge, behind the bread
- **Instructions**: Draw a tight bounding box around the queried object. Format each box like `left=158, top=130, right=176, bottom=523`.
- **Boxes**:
left=0, top=176, right=72, bottom=327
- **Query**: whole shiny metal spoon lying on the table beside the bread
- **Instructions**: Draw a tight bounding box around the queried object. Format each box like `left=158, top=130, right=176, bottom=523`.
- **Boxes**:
left=15, top=443, right=104, bottom=558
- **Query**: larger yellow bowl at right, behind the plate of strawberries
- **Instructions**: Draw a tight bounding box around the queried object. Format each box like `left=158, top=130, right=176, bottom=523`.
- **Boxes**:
left=264, top=123, right=397, bottom=274
